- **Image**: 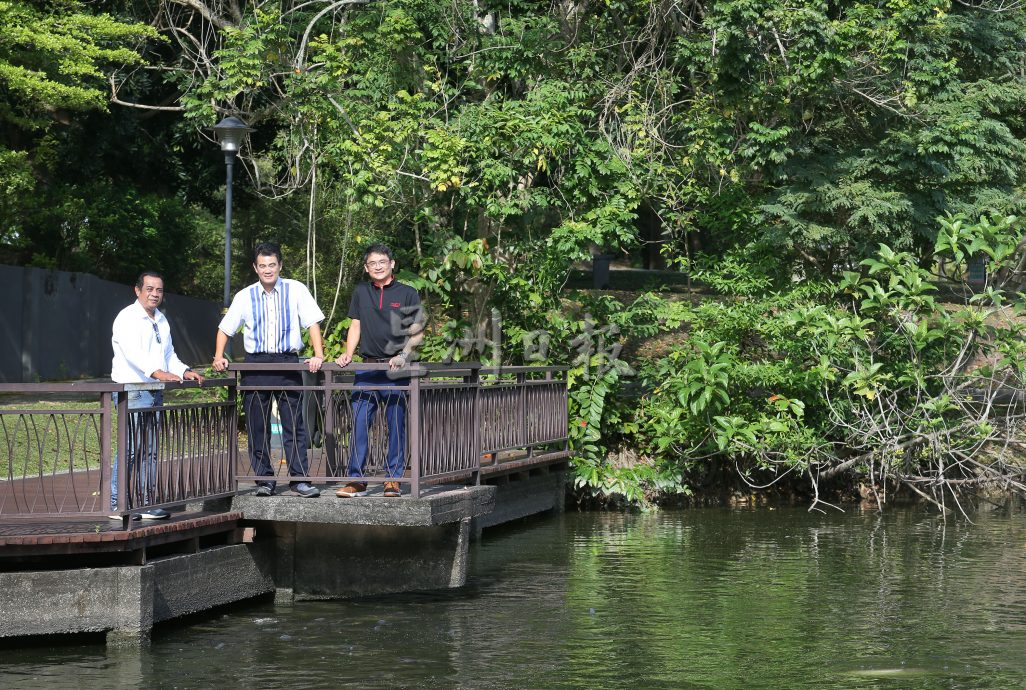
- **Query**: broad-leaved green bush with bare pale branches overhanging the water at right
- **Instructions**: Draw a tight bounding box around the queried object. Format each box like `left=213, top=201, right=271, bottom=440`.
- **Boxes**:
left=631, top=217, right=1026, bottom=504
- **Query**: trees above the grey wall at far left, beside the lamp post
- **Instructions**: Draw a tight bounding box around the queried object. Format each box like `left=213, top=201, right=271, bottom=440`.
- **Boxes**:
left=0, top=1, right=223, bottom=296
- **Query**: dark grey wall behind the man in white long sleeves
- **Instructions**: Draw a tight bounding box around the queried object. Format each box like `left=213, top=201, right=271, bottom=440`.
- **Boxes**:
left=0, top=266, right=221, bottom=383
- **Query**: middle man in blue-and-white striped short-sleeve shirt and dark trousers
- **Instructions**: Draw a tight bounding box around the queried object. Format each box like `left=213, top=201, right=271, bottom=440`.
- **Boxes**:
left=213, top=242, right=324, bottom=498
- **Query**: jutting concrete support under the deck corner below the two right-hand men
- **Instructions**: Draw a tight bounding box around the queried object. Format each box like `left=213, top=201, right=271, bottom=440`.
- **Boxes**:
left=238, top=486, right=496, bottom=604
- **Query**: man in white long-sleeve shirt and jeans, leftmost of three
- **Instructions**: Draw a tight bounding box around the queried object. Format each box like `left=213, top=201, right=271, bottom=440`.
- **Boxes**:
left=111, top=271, right=203, bottom=520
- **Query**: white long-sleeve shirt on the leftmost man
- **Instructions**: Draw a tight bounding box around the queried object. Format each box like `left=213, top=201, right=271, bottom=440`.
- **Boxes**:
left=111, top=299, right=189, bottom=383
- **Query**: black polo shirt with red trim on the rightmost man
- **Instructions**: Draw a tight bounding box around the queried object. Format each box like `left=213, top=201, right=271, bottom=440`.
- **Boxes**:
left=349, top=278, right=425, bottom=359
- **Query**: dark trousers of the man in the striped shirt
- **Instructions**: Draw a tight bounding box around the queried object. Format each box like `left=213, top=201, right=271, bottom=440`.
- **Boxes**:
left=241, top=354, right=309, bottom=486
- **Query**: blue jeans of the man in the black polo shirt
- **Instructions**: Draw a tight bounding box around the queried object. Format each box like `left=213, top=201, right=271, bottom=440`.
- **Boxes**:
left=346, top=371, right=409, bottom=479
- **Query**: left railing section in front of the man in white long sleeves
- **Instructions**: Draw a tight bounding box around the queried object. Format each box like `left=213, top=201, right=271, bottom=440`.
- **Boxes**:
left=0, top=379, right=237, bottom=518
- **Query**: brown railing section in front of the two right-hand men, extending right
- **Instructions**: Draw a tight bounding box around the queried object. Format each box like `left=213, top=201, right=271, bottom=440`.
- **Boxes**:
left=230, top=363, right=569, bottom=496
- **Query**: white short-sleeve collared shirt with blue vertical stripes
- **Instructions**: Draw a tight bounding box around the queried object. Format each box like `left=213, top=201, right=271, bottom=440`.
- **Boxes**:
left=218, top=278, right=324, bottom=353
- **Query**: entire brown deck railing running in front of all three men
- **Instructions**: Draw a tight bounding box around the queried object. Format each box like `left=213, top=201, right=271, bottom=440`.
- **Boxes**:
left=0, top=363, right=569, bottom=524
